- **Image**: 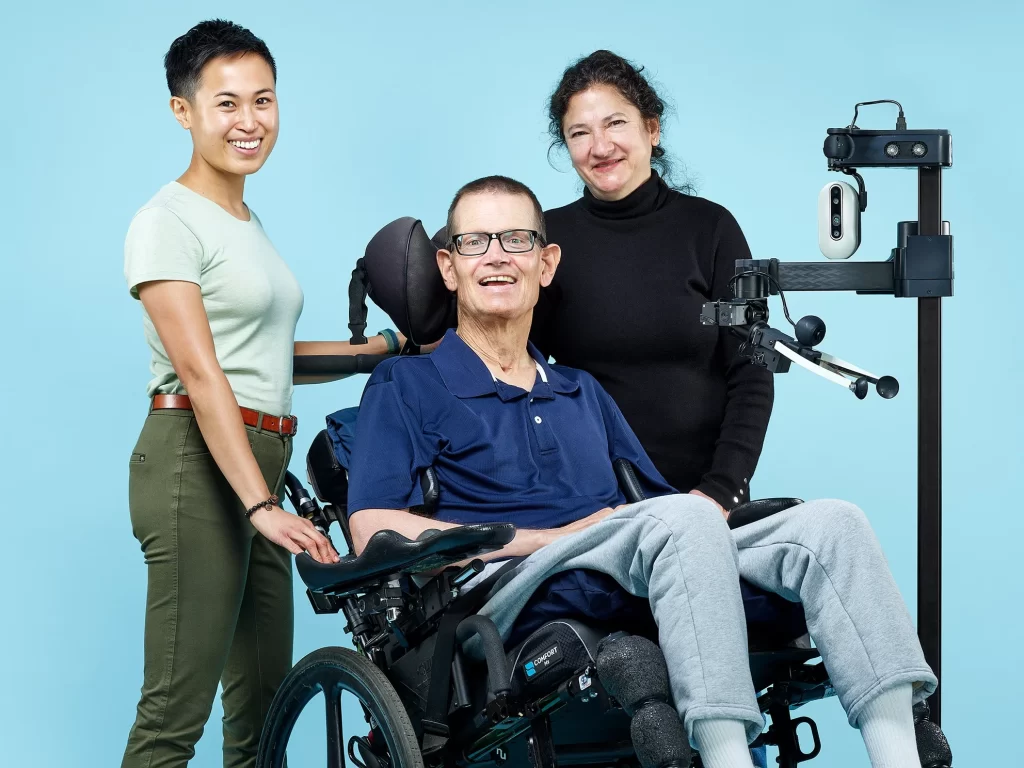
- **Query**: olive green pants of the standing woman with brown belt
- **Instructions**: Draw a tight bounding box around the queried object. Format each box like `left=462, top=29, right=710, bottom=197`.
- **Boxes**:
left=121, top=410, right=293, bottom=768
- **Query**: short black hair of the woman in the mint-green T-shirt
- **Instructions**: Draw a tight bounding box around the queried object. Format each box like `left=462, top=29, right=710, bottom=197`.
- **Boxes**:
left=164, top=18, right=278, bottom=101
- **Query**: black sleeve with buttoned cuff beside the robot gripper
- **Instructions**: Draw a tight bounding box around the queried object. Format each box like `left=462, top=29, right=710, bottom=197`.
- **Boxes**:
left=696, top=211, right=775, bottom=509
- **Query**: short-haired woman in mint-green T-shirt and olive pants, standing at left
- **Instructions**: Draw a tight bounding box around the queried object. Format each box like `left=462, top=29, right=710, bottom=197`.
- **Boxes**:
left=122, top=20, right=398, bottom=768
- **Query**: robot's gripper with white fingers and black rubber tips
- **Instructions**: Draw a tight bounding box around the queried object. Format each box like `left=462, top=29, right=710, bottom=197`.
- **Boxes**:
left=700, top=298, right=899, bottom=399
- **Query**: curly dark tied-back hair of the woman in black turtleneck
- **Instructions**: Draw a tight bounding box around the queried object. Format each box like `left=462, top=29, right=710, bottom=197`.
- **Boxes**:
left=548, top=50, right=693, bottom=194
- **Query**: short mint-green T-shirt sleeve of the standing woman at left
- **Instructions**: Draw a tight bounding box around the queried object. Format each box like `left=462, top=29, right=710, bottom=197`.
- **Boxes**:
left=125, top=208, right=203, bottom=299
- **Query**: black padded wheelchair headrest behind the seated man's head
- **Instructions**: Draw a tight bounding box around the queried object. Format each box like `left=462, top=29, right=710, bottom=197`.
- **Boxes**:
left=364, top=216, right=456, bottom=346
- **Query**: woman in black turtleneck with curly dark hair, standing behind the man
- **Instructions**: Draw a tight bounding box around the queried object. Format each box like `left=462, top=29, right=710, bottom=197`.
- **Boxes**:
left=531, top=51, right=773, bottom=511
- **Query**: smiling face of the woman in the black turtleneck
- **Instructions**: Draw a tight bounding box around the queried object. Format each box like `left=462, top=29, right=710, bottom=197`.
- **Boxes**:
left=562, top=85, right=660, bottom=200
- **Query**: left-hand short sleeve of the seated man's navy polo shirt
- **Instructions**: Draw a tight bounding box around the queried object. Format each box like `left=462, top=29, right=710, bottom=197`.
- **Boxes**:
left=348, top=378, right=432, bottom=515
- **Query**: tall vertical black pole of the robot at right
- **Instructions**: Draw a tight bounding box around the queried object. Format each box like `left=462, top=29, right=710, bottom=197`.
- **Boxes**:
left=918, top=167, right=943, bottom=725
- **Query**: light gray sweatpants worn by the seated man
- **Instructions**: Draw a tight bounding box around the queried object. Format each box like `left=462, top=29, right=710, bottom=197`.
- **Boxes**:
left=471, top=495, right=937, bottom=741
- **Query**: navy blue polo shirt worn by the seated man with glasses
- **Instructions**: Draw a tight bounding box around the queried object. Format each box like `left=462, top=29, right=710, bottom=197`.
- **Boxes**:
left=348, top=331, right=677, bottom=528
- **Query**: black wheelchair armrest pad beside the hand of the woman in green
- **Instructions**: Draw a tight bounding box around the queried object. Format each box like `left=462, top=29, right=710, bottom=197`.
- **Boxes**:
left=295, top=523, right=515, bottom=595
